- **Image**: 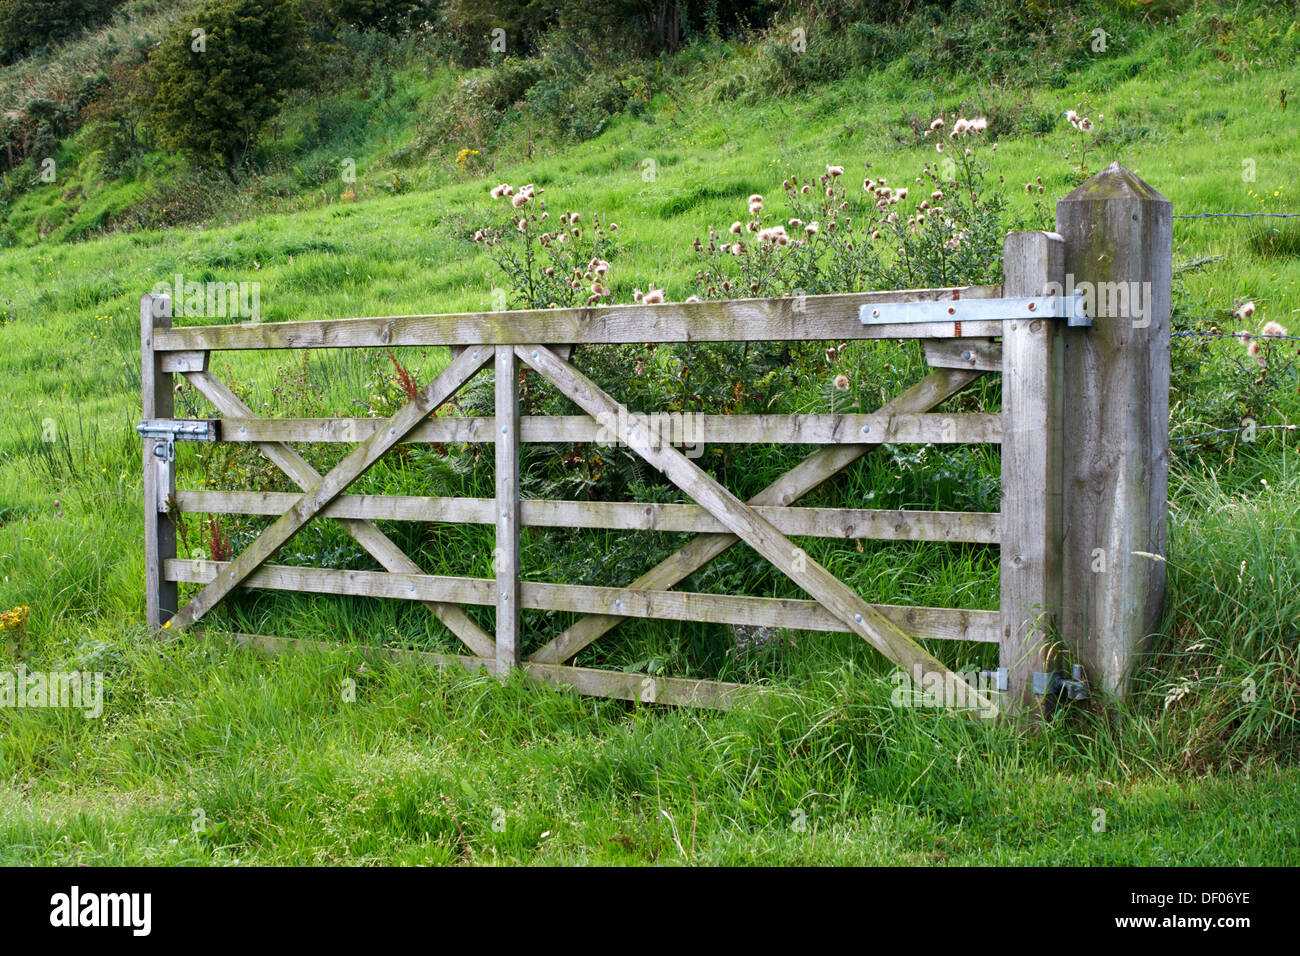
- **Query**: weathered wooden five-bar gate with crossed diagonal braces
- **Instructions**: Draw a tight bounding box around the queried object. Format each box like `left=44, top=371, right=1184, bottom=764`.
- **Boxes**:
left=140, top=192, right=1180, bottom=713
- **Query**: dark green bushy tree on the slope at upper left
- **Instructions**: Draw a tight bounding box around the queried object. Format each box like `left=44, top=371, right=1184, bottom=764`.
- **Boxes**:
left=150, top=0, right=306, bottom=177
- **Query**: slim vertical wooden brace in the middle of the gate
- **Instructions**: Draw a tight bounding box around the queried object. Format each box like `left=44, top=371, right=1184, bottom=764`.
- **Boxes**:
left=493, top=345, right=520, bottom=676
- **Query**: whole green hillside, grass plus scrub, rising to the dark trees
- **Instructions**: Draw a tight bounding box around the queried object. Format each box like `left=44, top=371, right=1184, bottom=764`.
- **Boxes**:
left=0, top=0, right=1300, bottom=865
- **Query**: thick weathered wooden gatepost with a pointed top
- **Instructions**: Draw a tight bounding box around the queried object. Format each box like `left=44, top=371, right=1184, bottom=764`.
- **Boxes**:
left=1057, top=163, right=1173, bottom=697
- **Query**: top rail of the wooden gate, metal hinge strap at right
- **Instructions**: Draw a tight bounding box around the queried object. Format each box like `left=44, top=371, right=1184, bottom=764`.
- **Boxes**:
left=153, top=285, right=1003, bottom=352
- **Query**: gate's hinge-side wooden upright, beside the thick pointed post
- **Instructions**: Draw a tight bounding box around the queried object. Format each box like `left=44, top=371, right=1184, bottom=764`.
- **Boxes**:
left=1000, top=233, right=1065, bottom=715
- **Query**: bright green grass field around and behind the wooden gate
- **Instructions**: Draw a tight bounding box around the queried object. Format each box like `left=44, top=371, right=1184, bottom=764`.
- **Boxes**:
left=0, top=3, right=1300, bottom=865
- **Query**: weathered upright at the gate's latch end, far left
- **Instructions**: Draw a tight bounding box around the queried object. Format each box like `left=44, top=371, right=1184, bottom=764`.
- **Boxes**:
left=140, top=295, right=177, bottom=627
